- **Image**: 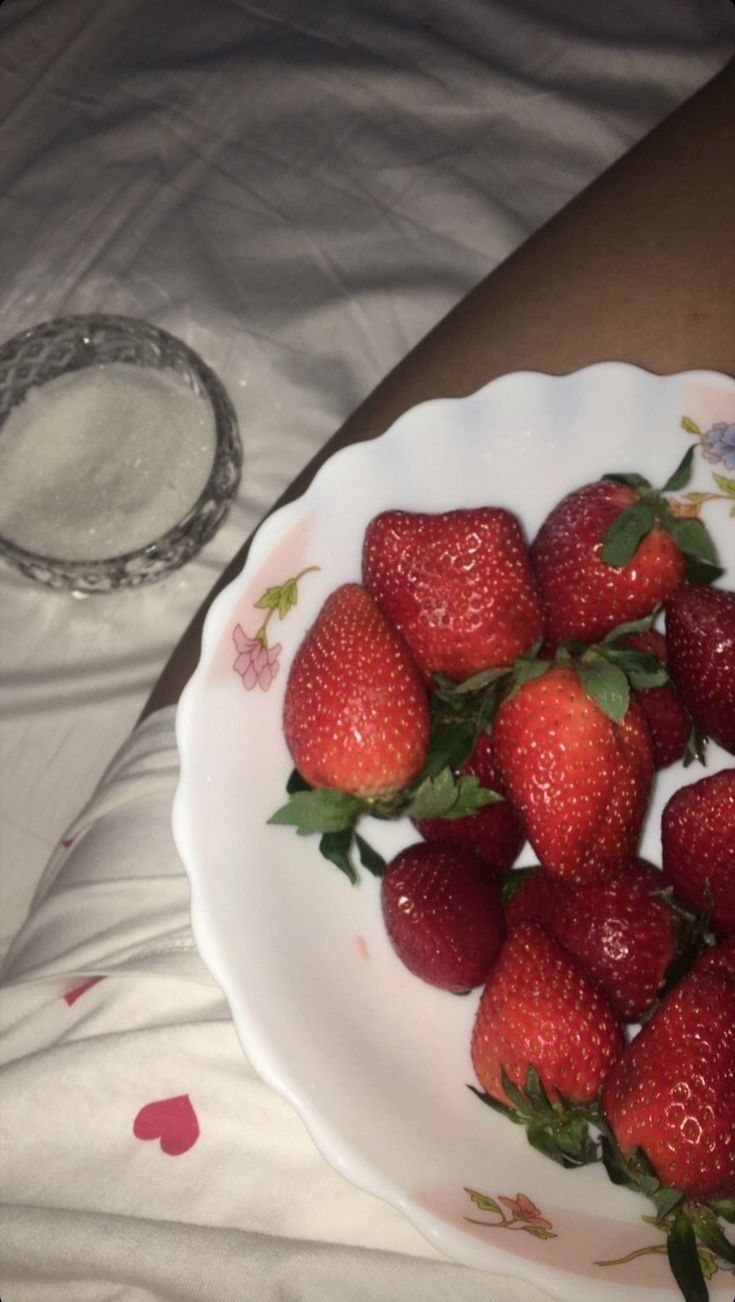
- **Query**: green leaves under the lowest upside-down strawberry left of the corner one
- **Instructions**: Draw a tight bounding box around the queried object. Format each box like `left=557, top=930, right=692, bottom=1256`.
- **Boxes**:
left=467, top=1064, right=601, bottom=1169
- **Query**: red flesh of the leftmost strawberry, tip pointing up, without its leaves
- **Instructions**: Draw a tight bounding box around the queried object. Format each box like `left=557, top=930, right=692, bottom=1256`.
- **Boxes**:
left=284, top=583, right=429, bottom=797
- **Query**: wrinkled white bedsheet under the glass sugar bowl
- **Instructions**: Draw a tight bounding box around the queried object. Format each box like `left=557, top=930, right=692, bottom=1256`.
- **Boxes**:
left=0, top=0, right=735, bottom=979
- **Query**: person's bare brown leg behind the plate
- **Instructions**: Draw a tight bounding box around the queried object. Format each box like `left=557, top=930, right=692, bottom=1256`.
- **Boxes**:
left=143, top=55, right=735, bottom=715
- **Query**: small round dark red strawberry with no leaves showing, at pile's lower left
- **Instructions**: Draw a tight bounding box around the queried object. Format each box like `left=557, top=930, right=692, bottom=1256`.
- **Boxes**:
left=381, top=841, right=505, bottom=993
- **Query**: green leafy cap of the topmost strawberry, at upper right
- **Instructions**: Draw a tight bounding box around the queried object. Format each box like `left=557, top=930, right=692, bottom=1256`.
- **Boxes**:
left=601, top=447, right=725, bottom=583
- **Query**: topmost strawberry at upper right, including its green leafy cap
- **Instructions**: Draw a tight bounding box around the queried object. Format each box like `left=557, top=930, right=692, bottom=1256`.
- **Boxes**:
left=531, top=448, right=722, bottom=647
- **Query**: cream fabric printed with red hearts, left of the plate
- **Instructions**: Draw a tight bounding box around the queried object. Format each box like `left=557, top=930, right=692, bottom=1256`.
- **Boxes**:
left=0, top=710, right=551, bottom=1302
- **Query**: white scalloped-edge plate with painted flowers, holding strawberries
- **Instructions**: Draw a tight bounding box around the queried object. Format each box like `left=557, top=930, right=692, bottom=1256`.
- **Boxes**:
left=174, top=363, right=735, bottom=1302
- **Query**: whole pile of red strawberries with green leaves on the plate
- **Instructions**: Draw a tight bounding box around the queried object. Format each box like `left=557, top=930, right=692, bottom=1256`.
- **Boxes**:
left=272, top=453, right=735, bottom=1299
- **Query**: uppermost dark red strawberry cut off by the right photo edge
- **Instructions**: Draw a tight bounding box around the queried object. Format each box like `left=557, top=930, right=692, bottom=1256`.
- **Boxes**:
left=666, top=586, right=735, bottom=755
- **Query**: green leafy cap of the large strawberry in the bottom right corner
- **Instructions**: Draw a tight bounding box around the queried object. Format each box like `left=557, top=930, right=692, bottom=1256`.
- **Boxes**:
left=600, top=1122, right=735, bottom=1302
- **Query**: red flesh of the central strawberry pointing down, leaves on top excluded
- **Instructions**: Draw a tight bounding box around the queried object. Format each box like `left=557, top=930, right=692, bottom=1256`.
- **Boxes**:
left=493, top=665, right=653, bottom=884
